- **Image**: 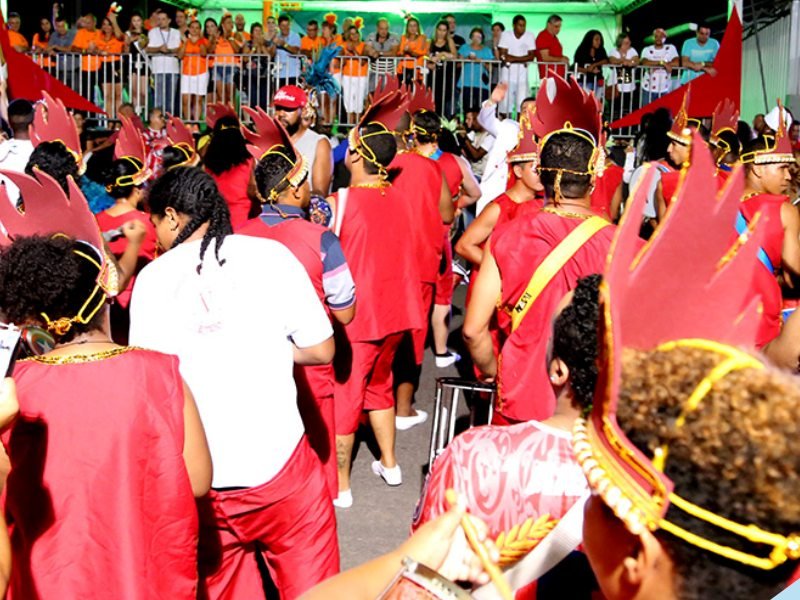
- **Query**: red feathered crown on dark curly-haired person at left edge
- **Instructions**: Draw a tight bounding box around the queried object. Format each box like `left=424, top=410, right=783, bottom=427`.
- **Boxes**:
left=0, top=167, right=119, bottom=335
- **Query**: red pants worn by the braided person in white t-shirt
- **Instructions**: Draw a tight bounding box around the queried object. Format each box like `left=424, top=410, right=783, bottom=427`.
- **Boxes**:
left=200, top=437, right=339, bottom=600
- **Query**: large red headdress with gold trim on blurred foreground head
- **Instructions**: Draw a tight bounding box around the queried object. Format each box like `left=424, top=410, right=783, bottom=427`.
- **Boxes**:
left=573, top=132, right=798, bottom=569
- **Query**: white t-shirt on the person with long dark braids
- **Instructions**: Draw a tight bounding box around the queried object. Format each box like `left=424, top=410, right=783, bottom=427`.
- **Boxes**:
left=130, top=235, right=333, bottom=488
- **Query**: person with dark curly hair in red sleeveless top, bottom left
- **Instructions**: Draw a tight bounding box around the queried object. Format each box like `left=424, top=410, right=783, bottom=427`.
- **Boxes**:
left=0, top=232, right=211, bottom=600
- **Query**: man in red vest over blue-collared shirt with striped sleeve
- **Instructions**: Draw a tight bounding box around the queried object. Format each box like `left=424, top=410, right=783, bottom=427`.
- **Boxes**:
left=236, top=108, right=356, bottom=499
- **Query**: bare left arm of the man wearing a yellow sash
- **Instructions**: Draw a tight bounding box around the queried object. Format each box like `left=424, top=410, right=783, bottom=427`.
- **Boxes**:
left=462, top=239, right=502, bottom=382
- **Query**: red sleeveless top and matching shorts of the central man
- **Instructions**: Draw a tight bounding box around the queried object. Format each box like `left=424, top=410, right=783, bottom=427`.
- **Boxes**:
left=333, top=185, right=426, bottom=435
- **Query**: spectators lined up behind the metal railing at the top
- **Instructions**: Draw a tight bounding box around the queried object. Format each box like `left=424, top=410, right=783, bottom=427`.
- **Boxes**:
left=8, top=9, right=719, bottom=124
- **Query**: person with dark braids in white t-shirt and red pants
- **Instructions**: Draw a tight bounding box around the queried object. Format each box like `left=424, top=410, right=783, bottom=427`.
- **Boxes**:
left=131, top=166, right=339, bottom=598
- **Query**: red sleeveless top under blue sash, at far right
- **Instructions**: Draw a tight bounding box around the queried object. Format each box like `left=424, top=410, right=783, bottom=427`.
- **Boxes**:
left=740, top=194, right=788, bottom=348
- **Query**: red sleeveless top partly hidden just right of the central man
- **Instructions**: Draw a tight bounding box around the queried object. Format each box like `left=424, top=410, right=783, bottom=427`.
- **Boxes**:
left=389, top=152, right=443, bottom=283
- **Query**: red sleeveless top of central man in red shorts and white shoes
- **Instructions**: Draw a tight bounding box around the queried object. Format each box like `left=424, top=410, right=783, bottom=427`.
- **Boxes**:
left=333, top=185, right=425, bottom=342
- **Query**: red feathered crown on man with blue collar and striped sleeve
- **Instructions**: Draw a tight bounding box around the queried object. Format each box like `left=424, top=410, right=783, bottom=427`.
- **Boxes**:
left=242, top=106, right=308, bottom=202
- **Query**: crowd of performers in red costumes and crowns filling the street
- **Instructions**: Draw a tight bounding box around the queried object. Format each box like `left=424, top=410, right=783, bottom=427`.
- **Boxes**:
left=0, top=2, right=800, bottom=600
